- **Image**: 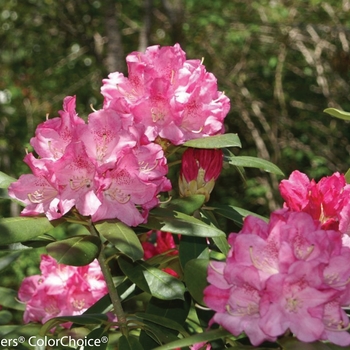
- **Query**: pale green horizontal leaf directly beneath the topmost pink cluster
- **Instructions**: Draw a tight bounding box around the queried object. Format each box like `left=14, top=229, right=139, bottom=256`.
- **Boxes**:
left=183, top=133, right=242, bottom=148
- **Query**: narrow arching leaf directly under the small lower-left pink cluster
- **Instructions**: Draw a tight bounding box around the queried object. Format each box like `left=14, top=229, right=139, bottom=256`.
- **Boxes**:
left=39, top=314, right=108, bottom=336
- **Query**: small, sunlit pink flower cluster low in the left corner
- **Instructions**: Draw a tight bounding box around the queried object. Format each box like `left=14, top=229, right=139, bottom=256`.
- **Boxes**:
left=18, top=255, right=108, bottom=327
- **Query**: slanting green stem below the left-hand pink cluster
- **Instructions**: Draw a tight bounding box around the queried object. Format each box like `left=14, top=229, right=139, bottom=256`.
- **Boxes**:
left=89, top=222, right=128, bottom=337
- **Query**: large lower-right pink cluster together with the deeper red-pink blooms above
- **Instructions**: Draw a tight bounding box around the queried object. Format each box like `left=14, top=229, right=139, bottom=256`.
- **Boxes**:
left=204, top=173, right=350, bottom=346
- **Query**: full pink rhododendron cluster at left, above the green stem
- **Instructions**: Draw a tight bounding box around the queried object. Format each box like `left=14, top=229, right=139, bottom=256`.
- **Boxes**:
left=9, top=96, right=171, bottom=226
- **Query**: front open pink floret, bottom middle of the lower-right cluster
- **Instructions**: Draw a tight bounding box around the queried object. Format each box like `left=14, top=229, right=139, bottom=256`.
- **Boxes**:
left=260, top=261, right=338, bottom=342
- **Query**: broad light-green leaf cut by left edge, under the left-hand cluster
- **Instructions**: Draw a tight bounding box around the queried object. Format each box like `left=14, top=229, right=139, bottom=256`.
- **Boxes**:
left=0, top=216, right=57, bottom=245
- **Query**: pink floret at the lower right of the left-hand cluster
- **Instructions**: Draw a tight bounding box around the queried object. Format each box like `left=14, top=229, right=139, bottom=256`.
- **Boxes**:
left=92, top=150, right=158, bottom=226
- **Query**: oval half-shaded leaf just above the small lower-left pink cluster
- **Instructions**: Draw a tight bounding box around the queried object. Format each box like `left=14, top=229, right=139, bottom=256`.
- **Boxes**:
left=46, top=235, right=101, bottom=266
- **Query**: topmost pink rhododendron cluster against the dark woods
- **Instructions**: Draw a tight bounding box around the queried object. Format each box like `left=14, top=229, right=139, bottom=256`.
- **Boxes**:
left=101, top=44, right=230, bottom=145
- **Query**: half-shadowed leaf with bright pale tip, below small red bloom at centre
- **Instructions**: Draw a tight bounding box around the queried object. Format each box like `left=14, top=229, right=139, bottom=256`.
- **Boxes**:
left=118, top=256, right=185, bottom=300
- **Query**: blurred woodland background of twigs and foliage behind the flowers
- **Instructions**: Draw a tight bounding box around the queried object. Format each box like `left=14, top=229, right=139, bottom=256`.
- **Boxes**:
left=0, top=0, right=350, bottom=224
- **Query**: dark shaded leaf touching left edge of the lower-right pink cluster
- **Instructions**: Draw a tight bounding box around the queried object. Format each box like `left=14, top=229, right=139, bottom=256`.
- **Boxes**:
left=184, top=259, right=209, bottom=305
